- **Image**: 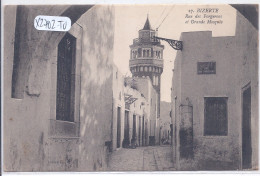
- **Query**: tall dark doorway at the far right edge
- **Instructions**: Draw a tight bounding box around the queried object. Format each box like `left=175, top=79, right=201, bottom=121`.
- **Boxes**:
left=242, top=86, right=252, bottom=169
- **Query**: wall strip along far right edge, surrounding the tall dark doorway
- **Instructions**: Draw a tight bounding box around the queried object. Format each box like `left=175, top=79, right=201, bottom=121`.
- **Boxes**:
left=236, top=12, right=259, bottom=169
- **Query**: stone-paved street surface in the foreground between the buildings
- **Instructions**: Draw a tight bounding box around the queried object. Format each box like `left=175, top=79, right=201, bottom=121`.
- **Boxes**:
left=108, top=146, right=174, bottom=171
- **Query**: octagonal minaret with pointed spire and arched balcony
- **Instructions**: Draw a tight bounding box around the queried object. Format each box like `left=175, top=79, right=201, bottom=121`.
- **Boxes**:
left=129, top=16, right=164, bottom=118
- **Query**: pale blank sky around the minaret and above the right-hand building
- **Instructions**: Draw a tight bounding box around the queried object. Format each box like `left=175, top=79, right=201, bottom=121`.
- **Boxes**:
left=114, top=5, right=236, bottom=102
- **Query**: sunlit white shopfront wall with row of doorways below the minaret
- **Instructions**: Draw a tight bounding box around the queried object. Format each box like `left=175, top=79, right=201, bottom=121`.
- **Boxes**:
left=113, top=69, right=150, bottom=150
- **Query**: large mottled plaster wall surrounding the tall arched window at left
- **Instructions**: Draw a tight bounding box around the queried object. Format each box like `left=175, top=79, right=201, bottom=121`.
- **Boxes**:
left=3, top=6, right=114, bottom=171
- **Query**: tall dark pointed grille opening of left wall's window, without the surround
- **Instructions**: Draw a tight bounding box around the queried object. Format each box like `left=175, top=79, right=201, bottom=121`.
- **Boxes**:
left=56, top=33, right=76, bottom=122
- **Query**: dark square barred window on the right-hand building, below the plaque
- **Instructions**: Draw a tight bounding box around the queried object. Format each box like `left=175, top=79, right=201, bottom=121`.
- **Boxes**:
left=204, top=97, right=228, bottom=136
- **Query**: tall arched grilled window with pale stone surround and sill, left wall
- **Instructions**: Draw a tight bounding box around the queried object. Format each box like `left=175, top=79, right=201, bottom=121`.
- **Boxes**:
left=49, top=24, right=82, bottom=138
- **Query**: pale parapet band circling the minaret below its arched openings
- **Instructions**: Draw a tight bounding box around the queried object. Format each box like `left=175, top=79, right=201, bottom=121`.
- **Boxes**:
left=129, top=58, right=163, bottom=68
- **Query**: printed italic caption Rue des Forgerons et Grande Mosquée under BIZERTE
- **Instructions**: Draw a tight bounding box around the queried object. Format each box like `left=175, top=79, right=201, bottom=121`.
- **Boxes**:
left=185, top=8, right=223, bottom=25
